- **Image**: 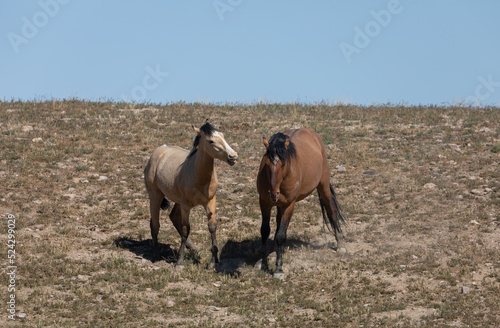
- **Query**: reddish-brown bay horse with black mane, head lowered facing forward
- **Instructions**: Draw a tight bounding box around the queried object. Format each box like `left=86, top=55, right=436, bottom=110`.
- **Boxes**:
left=257, top=128, right=346, bottom=280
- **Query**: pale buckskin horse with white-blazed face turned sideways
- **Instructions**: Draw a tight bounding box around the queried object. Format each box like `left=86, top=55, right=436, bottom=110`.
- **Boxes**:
left=144, top=120, right=238, bottom=268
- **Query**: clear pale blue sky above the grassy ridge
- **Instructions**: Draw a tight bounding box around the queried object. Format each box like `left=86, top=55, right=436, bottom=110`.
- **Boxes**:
left=0, top=0, right=500, bottom=106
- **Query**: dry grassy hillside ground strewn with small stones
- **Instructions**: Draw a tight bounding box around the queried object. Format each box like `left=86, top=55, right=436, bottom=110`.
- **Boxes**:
left=0, top=100, right=500, bottom=327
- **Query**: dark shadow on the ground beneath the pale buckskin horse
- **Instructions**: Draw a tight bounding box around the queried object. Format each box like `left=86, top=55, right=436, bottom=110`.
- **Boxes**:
left=113, top=237, right=177, bottom=263
